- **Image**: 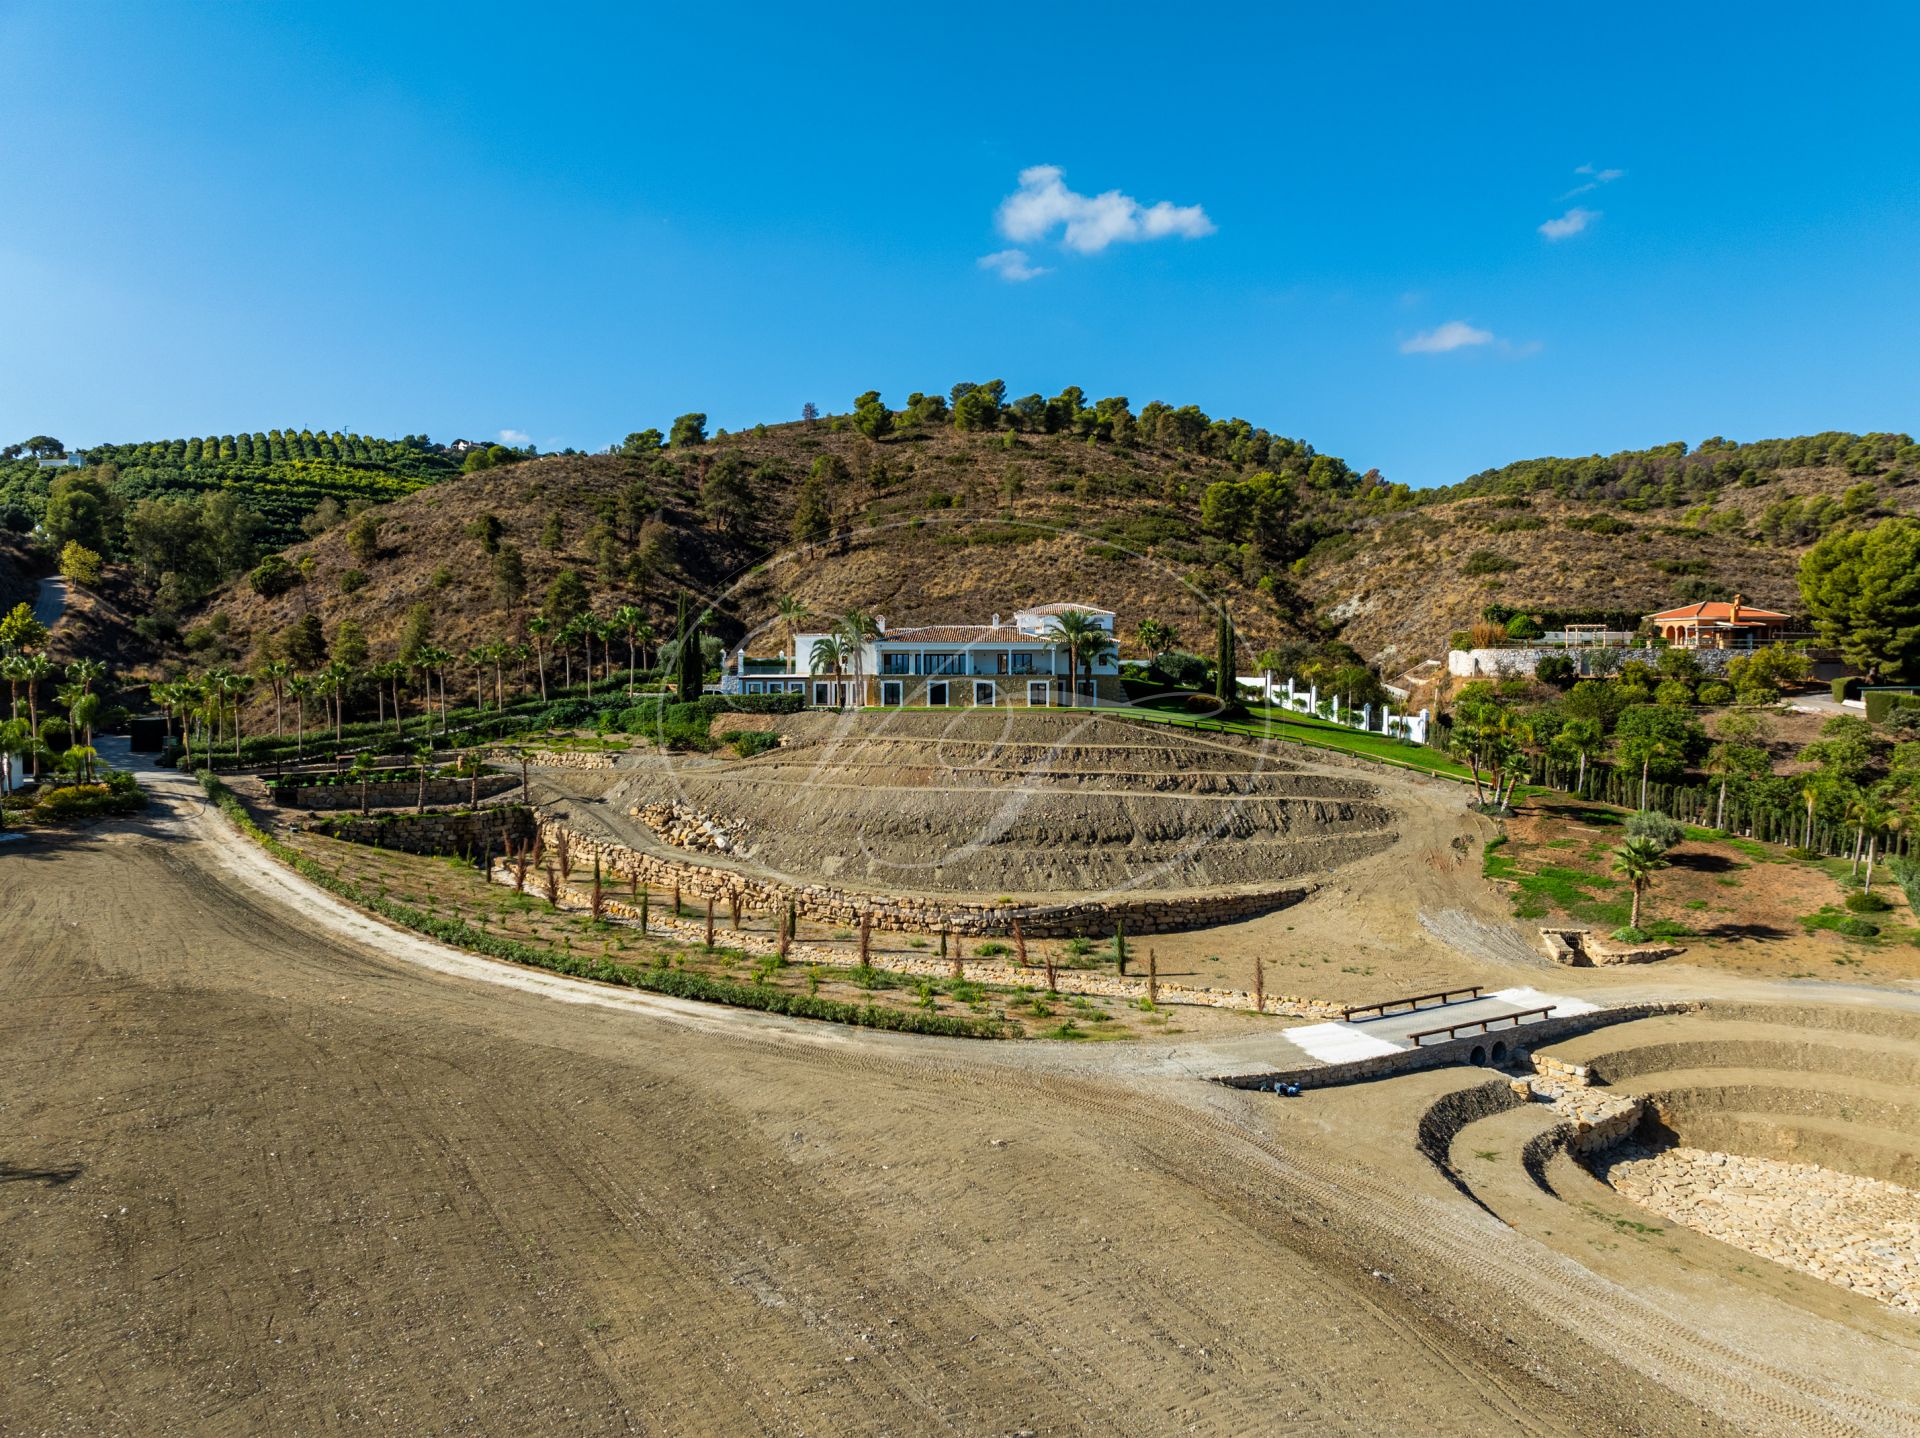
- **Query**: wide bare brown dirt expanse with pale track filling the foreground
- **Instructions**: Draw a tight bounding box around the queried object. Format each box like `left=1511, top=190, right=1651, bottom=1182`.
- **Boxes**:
left=0, top=779, right=1916, bottom=1434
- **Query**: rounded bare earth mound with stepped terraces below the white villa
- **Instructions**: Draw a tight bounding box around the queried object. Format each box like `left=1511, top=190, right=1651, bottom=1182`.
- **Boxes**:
left=579, top=710, right=1398, bottom=897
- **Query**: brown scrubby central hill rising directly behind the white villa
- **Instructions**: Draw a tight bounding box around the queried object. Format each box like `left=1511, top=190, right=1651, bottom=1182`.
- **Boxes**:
left=188, top=407, right=1352, bottom=671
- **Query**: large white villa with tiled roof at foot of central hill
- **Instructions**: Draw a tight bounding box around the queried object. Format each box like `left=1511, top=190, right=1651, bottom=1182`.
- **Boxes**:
left=720, top=605, right=1125, bottom=708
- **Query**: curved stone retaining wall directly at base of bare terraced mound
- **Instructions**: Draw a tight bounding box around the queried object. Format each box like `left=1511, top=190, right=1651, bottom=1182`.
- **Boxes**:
left=540, top=818, right=1311, bottom=939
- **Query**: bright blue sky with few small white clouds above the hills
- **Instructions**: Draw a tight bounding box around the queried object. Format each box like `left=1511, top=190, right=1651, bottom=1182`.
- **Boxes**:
left=0, top=4, right=1920, bottom=484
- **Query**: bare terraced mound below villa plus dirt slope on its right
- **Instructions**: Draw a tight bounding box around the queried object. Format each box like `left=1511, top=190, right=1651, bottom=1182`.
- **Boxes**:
left=536, top=710, right=1528, bottom=1002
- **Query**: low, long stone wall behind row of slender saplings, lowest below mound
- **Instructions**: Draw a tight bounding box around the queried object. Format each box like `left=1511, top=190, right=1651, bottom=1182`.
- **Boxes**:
left=490, top=860, right=1342, bottom=1019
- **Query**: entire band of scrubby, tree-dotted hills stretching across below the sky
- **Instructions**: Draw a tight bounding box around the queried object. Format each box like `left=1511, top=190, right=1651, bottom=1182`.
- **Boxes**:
left=0, top=395, right=1920, bottom=687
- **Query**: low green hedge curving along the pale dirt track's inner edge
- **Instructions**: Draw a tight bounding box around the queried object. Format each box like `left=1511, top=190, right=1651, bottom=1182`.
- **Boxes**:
left=200, top=770, right=1006, bottom=1039
